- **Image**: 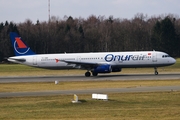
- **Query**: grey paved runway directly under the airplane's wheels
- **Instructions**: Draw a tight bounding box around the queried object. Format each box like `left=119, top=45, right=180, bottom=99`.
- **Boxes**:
left=0, top=73, right=180, bottom=83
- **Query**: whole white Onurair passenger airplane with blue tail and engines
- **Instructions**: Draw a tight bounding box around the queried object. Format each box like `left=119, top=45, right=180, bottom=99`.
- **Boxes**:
left=8, top=32, right=176, bottom=77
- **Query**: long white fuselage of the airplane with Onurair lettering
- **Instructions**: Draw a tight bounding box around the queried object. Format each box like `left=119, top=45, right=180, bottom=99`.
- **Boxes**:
left=8, top=51, right=176, bottom=69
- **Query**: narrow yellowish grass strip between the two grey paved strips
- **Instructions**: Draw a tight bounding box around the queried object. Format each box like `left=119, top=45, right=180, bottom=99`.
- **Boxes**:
left=0, top=80, right=180, bottom=92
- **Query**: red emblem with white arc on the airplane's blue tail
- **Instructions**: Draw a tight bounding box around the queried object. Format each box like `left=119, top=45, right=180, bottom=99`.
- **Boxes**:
left=14, top=37, right=30, bottom=54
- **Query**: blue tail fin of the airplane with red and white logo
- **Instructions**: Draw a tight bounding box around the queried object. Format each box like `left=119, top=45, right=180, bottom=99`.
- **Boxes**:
left=10, top=32, right=35, bottom=56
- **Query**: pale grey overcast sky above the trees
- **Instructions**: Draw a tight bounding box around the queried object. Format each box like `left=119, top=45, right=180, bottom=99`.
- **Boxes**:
left=0, top=0, right=180, bottom=23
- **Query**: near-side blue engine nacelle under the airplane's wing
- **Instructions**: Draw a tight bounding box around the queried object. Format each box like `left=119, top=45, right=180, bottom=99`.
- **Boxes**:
left=93, top=65, right=112, bottom=73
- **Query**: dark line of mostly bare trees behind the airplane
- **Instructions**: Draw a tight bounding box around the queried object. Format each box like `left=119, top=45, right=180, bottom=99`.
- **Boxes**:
left=0, top=14, right=180, bottom=59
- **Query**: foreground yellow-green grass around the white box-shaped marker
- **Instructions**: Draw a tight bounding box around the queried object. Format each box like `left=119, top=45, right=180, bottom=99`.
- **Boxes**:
left=0, top=92, right=180, bottom=120
